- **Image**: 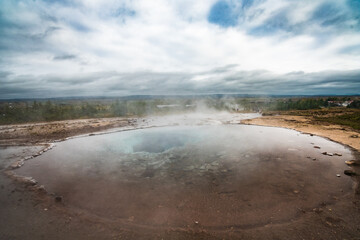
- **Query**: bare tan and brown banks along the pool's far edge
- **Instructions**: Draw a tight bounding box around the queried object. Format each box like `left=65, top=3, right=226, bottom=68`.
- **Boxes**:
left=0, top=114, right=360, bottom=152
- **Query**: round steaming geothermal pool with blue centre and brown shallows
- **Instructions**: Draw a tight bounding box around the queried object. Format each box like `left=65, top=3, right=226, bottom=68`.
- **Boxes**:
left=16, top=125, right=353, bottom=229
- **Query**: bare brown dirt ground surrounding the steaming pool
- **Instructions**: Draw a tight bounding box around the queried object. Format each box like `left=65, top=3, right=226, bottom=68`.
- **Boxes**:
left=0, top=115, right=360, bottom=239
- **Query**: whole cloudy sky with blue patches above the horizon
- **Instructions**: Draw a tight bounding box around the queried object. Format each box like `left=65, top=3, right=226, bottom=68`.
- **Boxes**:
left=0, top=0, right=360, bottom=99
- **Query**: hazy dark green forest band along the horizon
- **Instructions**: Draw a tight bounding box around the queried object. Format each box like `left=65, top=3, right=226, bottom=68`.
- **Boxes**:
left=0, top=97, right=360, bottom=124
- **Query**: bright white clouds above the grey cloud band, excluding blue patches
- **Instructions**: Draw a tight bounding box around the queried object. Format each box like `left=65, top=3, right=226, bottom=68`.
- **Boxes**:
left=0, top=0, right=360, bottom=97
